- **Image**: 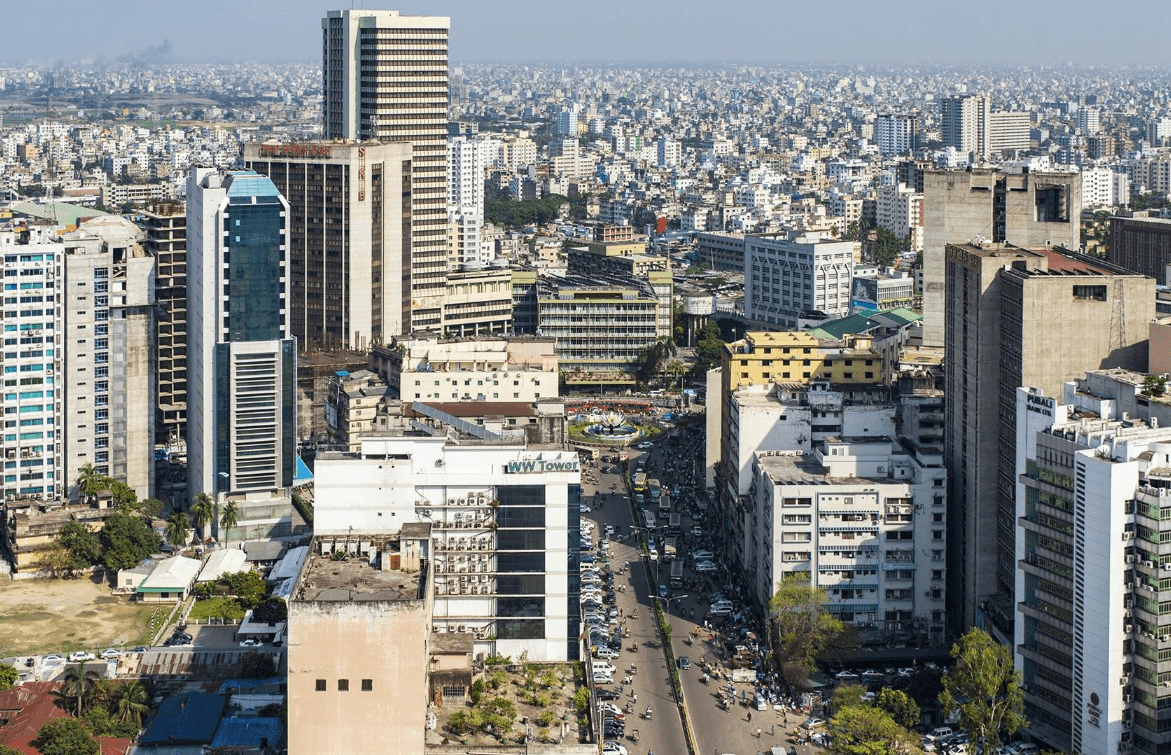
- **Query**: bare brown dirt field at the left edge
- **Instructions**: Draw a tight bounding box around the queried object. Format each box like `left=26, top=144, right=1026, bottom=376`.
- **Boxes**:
left=0, top=577, right=172, bottom=658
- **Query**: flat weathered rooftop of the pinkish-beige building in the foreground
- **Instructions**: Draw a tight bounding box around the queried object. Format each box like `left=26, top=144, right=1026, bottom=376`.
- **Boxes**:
left=293, top=533, right=426, bottom=602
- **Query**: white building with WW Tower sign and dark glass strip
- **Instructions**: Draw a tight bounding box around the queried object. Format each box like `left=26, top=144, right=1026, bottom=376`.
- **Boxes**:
left=314, top=437, right=581, bottom=661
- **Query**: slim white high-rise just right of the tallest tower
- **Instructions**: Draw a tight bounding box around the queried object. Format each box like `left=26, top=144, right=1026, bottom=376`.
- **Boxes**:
left=447, top=136, right=491, bottom=266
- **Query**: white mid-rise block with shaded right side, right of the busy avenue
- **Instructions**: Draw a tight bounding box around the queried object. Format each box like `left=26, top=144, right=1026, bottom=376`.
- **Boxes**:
left=745, top=438, right=947, bottom=644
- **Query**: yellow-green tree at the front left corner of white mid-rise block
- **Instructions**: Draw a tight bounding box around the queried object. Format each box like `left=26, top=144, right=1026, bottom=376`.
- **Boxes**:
left=768, top=578, right=845, bottom=673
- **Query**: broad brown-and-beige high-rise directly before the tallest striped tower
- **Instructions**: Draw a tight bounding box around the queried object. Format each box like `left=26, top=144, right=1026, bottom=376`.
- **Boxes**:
left=244, top=142, right=412, bottom=352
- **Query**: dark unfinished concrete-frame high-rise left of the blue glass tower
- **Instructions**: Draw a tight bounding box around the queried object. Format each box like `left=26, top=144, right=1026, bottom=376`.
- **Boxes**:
left=138, top=201, right=187, bottom=442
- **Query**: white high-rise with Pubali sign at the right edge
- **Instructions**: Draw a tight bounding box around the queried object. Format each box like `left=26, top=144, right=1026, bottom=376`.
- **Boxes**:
left=1013, top=370, right=1171, bottom=755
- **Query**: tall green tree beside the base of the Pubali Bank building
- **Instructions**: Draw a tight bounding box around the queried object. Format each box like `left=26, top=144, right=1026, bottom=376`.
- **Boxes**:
left=939, top=629, right=1028, bottom=753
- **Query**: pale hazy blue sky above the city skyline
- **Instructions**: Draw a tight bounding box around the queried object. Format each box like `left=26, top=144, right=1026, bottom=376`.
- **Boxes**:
left=9, top=0, right=1171, bottom=66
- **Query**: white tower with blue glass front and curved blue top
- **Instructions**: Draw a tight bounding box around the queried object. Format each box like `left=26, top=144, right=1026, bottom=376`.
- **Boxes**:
left=187, top=167, right=296, bottom=496
